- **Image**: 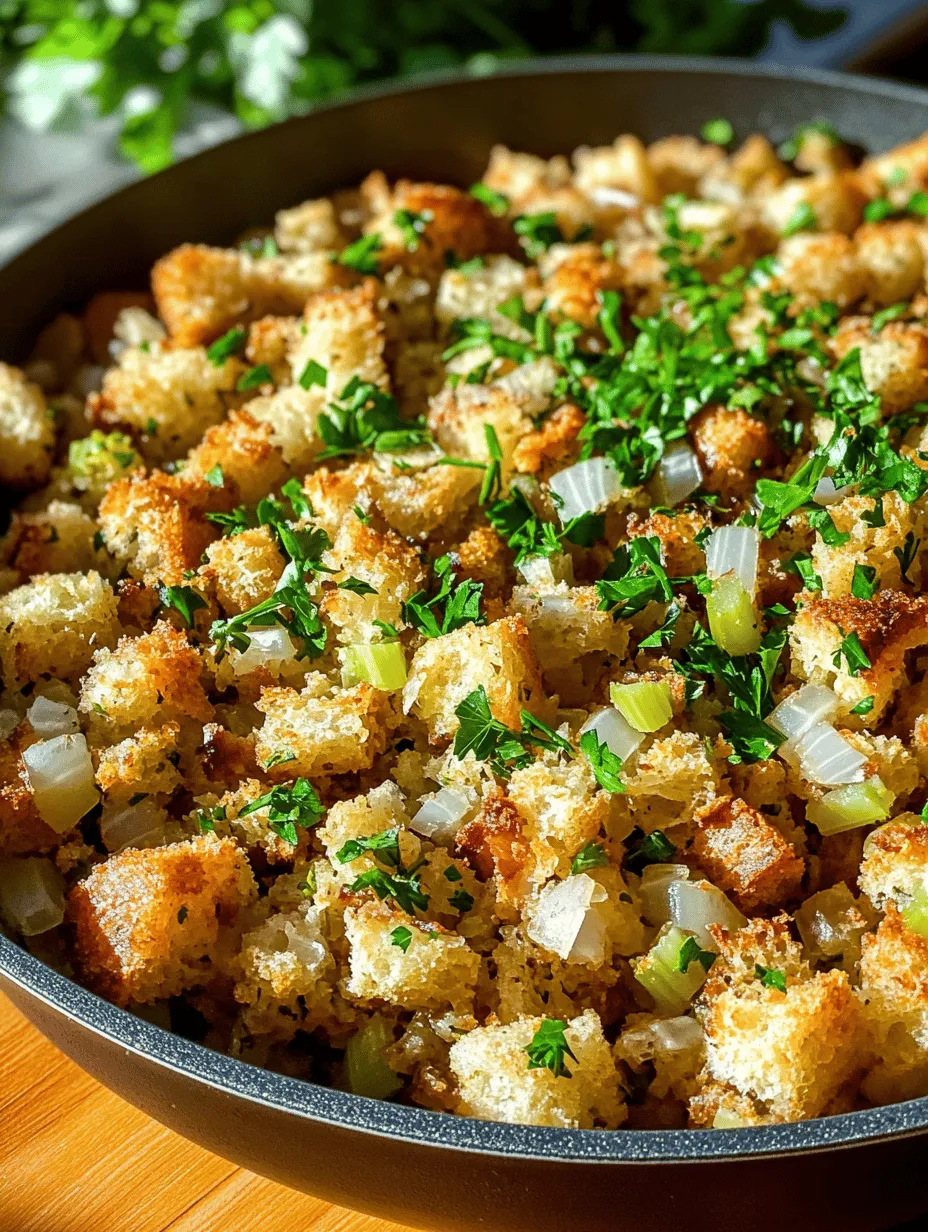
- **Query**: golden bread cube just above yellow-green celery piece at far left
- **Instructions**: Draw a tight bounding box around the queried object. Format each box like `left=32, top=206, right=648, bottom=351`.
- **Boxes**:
left=88, top=344, right=243, bottom=462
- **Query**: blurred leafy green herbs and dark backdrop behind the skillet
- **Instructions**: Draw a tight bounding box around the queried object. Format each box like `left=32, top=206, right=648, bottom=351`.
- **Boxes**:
left=0, top=0, right=845, bottom=171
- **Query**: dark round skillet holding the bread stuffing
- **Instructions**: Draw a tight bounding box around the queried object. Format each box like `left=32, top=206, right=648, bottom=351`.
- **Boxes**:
left=0, top=57, right=928, bottom=1232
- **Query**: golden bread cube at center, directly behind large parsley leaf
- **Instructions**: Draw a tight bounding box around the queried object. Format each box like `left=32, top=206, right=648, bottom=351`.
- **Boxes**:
left=403, top=616, right=545, bottom=740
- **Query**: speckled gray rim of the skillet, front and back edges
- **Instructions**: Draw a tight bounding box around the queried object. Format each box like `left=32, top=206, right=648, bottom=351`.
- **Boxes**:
left=0, top=53, right=928, bottom=1165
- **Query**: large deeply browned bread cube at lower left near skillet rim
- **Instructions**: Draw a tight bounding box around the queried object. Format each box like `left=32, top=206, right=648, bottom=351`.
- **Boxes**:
left=68, top=835, right=258, bottom=1005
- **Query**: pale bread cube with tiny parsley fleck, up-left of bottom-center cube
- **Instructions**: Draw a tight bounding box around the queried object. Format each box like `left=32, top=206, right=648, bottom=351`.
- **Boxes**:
left=344, top=902, right=481, bottom=1013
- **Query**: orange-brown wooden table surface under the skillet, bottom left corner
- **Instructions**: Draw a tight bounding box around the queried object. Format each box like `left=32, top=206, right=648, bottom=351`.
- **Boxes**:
left=0, top=995, right=408, bottom=1232
